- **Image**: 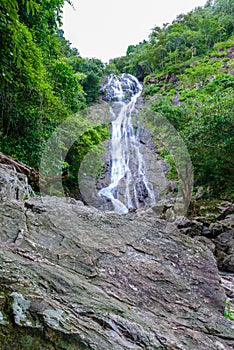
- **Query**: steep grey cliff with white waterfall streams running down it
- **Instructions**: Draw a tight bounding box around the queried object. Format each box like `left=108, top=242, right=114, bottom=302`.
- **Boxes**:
left=79, top=74, right=169, bottom=213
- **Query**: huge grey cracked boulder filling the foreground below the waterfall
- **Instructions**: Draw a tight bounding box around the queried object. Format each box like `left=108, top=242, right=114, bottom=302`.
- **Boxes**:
left=0, top=166, right=234, bottom=350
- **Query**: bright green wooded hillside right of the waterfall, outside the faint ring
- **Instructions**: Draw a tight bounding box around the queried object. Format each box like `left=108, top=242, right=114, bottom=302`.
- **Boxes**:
left=111, top=0, right=234, bottom=197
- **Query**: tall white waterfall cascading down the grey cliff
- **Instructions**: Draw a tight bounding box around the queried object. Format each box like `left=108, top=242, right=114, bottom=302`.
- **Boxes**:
left=99, top=74, right=155, bottom=213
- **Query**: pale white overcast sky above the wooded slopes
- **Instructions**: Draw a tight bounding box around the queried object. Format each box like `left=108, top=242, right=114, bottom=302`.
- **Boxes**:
left=62, top=0, right=207, bottom=63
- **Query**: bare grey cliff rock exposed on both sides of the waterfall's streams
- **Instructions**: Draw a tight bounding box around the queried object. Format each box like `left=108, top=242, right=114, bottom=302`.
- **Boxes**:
left=79, top=106, right=172, bottom=210
